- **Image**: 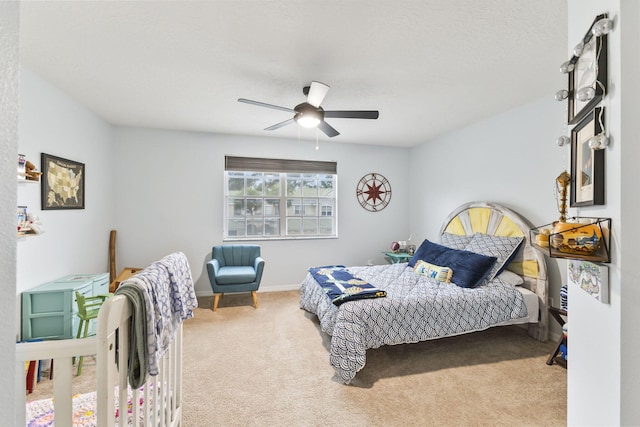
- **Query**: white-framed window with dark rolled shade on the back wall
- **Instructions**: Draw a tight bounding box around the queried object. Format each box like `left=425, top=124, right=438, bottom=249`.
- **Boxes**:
left=224, top=156, right=338, bottom=239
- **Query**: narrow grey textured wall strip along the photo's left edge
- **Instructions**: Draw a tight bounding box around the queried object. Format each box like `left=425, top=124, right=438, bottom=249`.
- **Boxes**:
left=0, top=2, right=18, bottom=424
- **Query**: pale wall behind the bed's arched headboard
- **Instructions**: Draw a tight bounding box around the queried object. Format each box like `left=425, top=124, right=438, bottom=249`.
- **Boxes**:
left=409, top=97, right=565, bottom=318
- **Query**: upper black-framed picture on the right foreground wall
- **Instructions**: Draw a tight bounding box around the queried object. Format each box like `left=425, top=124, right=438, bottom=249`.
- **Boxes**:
left=567, top=13, right=607, bottom=125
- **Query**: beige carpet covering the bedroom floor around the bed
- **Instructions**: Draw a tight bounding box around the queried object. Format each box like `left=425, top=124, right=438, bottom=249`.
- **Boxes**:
left=25, top=291, right=566, bottom=427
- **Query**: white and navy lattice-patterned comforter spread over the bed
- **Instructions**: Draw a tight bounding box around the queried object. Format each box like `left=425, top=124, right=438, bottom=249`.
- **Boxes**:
left=300, top=263, right=527, bottom=383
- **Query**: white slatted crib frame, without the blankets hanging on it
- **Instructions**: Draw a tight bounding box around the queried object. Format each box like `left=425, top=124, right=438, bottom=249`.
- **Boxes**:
left=15, top=295, right=182, bottom=427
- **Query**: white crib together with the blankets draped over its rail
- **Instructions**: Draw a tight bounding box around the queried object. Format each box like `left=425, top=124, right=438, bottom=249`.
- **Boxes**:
left=16, top=252, right=197, bottom=427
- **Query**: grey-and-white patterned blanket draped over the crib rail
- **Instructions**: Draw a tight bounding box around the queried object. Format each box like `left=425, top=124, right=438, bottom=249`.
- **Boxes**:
left=116, top=252, right=198, bottom=386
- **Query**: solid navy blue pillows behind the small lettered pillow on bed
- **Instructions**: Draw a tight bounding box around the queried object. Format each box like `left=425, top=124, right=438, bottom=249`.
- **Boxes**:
left=408, top=239, right=496, bottom=288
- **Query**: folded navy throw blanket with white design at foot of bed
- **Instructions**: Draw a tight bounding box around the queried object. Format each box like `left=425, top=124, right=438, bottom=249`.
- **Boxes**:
left=309, top=265, right=387, bottom=305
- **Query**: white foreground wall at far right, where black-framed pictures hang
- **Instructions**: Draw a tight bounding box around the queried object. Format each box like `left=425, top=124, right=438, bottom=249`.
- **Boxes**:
left=567, top=0, right=640, bottom=425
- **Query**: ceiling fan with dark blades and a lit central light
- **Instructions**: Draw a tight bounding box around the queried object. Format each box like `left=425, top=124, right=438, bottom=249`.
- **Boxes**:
left=238, top=82, right=379, bottom=138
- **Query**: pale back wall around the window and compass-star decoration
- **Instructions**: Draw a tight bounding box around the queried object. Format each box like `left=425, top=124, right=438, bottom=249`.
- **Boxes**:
left=115, top=128, right=411, bottom=295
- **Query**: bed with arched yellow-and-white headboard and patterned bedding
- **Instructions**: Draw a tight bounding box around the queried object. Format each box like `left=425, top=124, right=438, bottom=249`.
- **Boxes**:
left=300, top=202, right=548, bottom=384
